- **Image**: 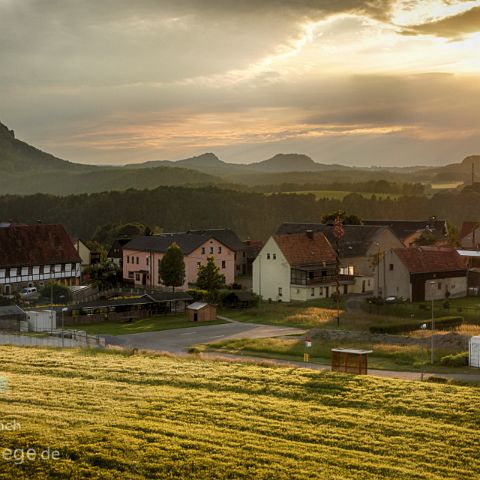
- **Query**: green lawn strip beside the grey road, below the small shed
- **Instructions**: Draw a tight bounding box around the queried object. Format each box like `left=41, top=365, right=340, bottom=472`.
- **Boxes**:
left=78, top=314, right=226, bottom=335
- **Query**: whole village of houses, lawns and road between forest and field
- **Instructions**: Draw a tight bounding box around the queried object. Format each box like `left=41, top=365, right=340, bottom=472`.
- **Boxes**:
left=0, top=215, right=480, bottom=380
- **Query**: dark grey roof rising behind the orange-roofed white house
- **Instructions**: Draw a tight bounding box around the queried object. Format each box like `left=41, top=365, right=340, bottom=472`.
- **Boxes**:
left=277, top=223, right=388, bottom=258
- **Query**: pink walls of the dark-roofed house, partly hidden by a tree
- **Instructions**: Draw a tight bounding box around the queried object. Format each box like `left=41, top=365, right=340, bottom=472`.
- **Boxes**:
left=123, top=239, right=235, bottom=289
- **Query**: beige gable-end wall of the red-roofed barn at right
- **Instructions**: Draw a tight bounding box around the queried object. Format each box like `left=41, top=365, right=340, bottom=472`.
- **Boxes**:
left=375, top=250, right=411, bottom=299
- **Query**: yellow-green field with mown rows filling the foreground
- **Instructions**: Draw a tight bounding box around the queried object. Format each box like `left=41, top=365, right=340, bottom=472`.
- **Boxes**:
left=0, top=347, right=480, bottom=480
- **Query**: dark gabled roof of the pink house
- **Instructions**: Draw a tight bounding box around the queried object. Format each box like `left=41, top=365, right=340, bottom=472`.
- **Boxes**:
left=123, top=232, right=236, bottom=255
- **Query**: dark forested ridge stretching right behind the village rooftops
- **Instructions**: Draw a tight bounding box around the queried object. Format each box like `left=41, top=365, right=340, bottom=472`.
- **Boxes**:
left=0, top=187, right=480, bottom=239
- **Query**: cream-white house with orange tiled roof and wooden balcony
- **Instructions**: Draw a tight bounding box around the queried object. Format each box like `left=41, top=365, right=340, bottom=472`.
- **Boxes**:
left=252, top=230, right=353, bottom=302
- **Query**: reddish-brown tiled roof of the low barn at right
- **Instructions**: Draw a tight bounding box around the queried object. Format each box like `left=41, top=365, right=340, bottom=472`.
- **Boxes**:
left=394, top=247, right=467, bottom=273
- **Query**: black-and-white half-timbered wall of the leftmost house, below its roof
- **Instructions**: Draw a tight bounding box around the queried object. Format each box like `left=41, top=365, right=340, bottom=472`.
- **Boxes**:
left=0, top=263, right=81, bottom=294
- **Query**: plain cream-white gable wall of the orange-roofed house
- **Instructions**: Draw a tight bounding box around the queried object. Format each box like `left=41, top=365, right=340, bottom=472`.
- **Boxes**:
left=252, top=237, right=291, bottom=302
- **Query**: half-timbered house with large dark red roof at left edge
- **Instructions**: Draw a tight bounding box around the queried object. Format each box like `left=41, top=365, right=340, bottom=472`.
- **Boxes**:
left=0, top=223, right=82, bottom=295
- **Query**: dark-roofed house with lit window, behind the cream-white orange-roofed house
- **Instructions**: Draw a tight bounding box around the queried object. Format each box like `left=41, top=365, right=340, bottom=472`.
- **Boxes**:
left=277, top=223, right=403, bottom=293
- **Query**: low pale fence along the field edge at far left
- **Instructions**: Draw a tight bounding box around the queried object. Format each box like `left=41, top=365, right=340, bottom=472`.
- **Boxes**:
left=0, top=330, right=105, bottom=348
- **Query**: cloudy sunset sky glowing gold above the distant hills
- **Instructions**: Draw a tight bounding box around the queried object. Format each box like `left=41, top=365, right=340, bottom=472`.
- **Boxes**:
left=0, top=0, right=480, bottom=166
